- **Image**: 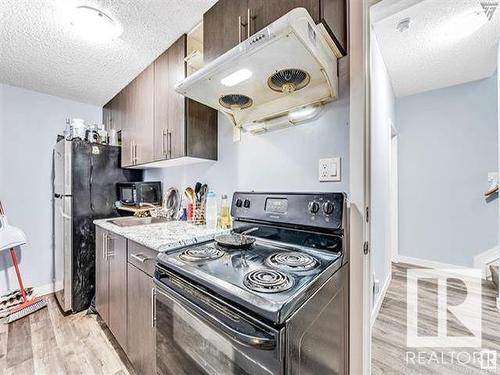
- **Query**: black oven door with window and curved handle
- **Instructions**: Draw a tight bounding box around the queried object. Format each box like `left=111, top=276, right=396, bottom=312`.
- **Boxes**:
left=154, top=280, right=284, bottom=375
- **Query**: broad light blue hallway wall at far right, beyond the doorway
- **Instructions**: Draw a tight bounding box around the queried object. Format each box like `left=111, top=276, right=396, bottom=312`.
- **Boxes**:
left=396, top=77, right=499, bottom=266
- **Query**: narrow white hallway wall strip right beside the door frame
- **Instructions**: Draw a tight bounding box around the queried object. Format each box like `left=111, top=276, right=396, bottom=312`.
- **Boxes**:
left=370, top=33, right=395, bottom=314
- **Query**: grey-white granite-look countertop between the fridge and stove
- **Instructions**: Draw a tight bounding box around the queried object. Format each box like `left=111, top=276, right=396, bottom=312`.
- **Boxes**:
left=94, top=218, right=228, bottom=252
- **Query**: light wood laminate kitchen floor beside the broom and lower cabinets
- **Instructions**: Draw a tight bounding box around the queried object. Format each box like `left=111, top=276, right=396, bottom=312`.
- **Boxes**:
left=0, top=295, right=134, bottom=375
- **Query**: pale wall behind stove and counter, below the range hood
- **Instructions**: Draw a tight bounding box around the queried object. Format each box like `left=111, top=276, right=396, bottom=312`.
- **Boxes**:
left=145, top=59, right=349, bottom=197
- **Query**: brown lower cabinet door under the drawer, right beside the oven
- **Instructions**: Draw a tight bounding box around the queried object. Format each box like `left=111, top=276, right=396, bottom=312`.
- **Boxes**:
left=127, top=263, right=156, bottom=375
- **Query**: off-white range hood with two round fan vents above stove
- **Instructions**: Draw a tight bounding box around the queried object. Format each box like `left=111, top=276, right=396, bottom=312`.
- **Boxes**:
left=175, top=8, right=338, bottom=128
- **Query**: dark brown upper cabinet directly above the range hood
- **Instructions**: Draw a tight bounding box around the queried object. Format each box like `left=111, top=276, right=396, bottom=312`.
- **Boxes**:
left=203, top=0, right=347, bottom=64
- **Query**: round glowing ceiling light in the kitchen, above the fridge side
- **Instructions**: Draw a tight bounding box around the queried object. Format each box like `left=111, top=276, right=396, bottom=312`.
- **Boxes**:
left=70, top=6, right=123, bottom=41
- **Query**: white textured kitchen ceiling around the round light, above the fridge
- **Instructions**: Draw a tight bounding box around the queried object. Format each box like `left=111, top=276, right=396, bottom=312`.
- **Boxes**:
left=0, top=0, right=216, bottom=105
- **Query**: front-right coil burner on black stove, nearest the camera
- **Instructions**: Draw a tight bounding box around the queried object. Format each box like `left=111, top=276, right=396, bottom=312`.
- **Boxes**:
left=243, top=269, right=293, bottom=293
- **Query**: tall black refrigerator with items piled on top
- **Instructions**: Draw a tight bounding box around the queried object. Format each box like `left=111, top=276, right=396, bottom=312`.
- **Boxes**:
left=53, top=139, right=143, bottom=312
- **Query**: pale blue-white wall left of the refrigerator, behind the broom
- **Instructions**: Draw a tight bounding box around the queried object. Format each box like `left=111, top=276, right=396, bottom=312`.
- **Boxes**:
left=0, top=85, right=102, bottom=293
